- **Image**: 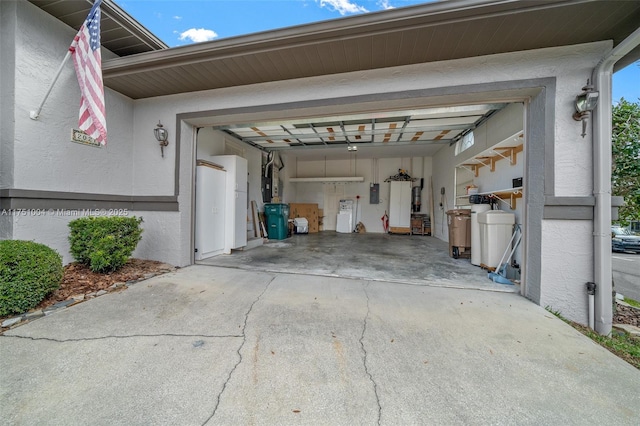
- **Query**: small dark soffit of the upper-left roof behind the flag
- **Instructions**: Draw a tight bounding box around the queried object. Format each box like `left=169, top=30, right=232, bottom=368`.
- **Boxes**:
left=29, top=0, right=168, bottom=57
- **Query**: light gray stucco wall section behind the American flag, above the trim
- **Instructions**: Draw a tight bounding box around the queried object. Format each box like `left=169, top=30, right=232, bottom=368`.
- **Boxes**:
left=13, top=1, right=133, bottom=194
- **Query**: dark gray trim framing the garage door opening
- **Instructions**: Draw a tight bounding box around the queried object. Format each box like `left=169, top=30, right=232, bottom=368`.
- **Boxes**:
left=176, top=77, right=556, bottom=284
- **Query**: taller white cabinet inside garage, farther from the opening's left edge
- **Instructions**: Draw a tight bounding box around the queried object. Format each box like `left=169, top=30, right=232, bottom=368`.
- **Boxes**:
left=208, top=155, right=249, bottom=254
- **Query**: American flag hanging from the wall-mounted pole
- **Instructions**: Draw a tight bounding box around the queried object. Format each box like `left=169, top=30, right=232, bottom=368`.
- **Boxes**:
left=69, top=0, right=107, bottom=145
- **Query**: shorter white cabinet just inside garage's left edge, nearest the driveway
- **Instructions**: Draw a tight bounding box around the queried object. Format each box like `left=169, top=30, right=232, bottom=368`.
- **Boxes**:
left=195, top=162, right=227, bottom=260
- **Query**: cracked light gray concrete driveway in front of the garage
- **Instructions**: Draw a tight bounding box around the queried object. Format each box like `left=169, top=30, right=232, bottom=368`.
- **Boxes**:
left=0, top=266, right=640, bottom=425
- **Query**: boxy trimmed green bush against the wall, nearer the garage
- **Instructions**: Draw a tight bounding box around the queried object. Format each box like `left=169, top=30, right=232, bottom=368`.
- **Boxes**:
left=69, top=216, right=142, bottom=272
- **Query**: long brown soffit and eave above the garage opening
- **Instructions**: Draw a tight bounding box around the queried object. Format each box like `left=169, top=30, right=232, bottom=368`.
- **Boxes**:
left=103, top=0, right=640, bottom=99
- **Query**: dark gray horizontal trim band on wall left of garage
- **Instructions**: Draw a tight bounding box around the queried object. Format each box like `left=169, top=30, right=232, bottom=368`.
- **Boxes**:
left=0, top=189, right=179, bottom=212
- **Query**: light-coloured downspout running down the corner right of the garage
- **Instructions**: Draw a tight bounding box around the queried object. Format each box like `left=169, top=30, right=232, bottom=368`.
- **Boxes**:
left=591, top=28, right=640, bottom=335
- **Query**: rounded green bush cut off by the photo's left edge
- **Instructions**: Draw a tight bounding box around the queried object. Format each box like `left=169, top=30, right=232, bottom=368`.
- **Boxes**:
left=0, top=240, right=64, bottom=316
